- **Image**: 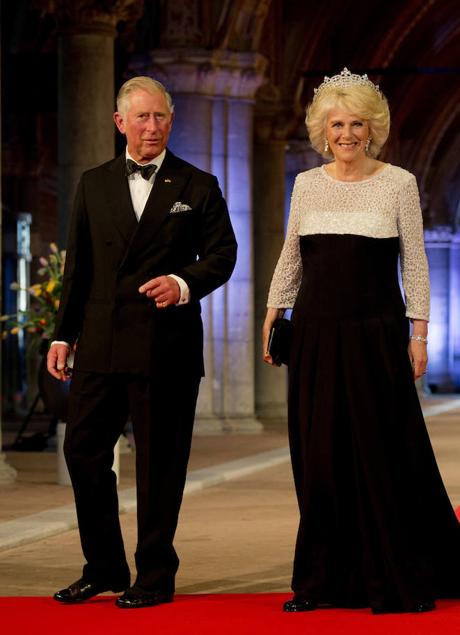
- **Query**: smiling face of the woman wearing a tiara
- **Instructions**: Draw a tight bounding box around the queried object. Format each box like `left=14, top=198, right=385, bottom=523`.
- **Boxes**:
left=326, top=108, right=370, bottom=162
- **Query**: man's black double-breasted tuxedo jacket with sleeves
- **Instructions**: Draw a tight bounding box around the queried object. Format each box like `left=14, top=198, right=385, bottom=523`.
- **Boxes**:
left=54, top=151, right=236, bottom=377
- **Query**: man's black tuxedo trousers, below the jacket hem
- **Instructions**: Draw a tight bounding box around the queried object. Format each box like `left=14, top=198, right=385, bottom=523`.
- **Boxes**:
left=64, top=371, right=200, bottom=592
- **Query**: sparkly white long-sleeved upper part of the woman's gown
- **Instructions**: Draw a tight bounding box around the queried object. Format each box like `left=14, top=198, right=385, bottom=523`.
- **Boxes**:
left=267, top=164, right=430, bottom=320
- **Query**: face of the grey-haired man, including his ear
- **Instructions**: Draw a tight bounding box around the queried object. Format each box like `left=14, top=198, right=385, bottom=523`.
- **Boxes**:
left=114, top=90, right=173, bottom=163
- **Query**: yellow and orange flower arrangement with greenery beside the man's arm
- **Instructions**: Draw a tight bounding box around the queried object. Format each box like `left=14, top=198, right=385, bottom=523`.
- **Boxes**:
left=0, top=243, right=66, bottom=344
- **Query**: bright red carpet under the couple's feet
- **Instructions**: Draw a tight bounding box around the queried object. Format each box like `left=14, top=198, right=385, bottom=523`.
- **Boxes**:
left=0, top=593, right=460, bottom=635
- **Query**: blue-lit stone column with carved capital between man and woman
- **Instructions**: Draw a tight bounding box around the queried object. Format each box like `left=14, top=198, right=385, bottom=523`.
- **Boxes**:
left=129, top=48, right=266, bottom=433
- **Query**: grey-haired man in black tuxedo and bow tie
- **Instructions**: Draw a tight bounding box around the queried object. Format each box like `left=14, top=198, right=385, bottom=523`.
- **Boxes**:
left=48, top=77, right=236, bottom=608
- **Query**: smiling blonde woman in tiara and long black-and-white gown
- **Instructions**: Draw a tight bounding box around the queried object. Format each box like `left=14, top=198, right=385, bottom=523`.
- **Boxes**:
left=263, top=69, right=460, bottom=613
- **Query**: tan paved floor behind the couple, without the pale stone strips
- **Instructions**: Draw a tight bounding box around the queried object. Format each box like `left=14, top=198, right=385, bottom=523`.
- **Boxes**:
left=0, top=399, right=460, bottom=595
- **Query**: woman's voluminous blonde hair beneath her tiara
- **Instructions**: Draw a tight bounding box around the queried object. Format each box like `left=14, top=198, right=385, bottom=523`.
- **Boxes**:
left=305, top=84, right=390, bottom=159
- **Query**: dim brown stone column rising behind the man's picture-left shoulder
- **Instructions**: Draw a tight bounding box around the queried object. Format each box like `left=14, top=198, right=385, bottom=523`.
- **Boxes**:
left=38, top=0, right=143, bottom=245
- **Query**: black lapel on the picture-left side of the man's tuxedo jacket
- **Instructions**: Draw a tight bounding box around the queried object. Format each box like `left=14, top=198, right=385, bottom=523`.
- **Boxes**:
left=104, top=153, right=138, bottom=243
